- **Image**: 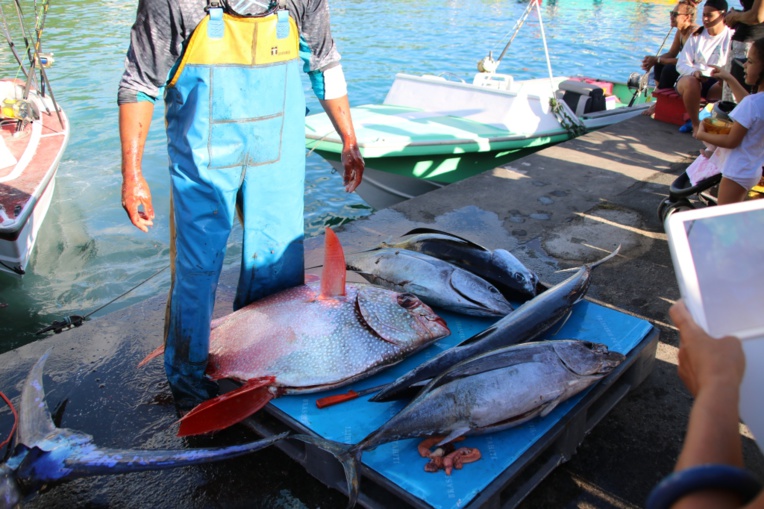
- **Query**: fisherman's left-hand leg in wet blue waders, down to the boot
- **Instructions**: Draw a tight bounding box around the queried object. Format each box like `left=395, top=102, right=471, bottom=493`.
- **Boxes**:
left=164, top=164, right=241, bottom=412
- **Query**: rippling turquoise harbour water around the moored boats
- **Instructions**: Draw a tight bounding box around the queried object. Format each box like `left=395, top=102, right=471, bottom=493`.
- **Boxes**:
left=0, top=0, right=671, bottom=352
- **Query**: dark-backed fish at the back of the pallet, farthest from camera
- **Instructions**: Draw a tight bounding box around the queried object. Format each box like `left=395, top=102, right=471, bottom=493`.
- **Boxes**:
left=382, top=228, right=539, bottom=301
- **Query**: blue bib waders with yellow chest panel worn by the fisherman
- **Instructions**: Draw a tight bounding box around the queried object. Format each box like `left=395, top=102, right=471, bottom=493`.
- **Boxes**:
left=165, top=4, right=305, bottom=409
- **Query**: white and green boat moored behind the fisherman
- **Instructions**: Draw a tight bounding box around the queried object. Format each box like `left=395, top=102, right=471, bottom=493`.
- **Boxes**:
left=305, top=2, right=650, bottom=209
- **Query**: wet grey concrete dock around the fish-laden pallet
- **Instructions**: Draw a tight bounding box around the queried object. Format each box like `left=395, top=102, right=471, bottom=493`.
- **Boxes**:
left=0, top=116, right=764, bottom=508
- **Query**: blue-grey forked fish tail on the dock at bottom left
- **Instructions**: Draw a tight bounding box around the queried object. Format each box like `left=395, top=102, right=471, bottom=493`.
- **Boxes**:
left=0, top=353, right=287, bottom=509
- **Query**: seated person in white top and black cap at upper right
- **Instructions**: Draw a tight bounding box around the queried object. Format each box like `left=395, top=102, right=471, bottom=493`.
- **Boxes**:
left=676, top=0, right=733, bottom=134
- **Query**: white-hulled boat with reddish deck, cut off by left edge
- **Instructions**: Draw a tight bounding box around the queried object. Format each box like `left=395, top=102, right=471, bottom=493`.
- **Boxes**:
left=0, top=79, right=69, bottom=275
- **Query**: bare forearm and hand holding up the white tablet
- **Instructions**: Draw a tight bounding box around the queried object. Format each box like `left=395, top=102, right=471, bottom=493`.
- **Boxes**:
left=669, top=301, right=764, bottom=509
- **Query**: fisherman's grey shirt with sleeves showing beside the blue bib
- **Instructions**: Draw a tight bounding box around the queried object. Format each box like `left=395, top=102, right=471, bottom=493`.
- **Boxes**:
left=117, top=0, right=344, bottom=104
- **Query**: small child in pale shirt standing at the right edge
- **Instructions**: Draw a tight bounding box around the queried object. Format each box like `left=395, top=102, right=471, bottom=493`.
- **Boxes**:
left=695, top=39, right=764, bottom=205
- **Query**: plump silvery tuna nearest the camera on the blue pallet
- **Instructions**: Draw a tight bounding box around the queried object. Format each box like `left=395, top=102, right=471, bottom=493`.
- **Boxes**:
left=292, top=340, right=625, bottom=507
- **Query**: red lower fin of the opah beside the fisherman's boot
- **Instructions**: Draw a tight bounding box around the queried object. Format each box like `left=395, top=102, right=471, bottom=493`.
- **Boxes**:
left=178, top=376, right=276, bottom=437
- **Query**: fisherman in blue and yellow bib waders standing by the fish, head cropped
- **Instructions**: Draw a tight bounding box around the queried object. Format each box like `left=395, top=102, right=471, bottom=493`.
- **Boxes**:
left=118, top=0, right=364, bottom=415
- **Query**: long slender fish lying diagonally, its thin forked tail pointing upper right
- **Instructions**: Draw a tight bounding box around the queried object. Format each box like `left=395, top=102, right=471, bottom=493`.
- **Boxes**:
left=371, top=246, right=620, bottom=401
